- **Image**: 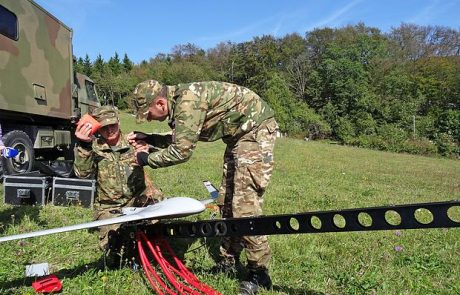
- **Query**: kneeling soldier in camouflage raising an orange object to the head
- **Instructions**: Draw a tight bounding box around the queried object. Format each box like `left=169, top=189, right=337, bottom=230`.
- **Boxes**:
left=74, top=106, right=164, bottom=266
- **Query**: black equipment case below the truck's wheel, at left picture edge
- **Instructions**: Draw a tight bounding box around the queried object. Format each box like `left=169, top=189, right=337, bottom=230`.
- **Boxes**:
left=3, top=171, right=52, bottom=205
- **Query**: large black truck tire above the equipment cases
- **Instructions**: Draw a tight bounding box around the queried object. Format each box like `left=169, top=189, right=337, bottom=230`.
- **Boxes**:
left=2, top=130, right=35, bottom=175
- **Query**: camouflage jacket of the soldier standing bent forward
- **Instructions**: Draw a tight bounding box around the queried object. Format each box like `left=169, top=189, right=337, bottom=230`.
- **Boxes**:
left=148, top=81, right=274, bottom=168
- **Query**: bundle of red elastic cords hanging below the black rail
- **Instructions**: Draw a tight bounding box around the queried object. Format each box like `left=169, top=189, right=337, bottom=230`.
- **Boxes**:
left=136, top=231, right=221, bottom=295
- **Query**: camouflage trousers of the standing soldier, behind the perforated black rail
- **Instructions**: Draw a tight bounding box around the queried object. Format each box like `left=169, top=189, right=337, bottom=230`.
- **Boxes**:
left=217, top=118, right=278, bottom=270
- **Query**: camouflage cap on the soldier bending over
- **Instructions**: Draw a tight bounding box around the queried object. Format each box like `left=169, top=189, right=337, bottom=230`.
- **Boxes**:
left=133, top=80, right=164, bottom=123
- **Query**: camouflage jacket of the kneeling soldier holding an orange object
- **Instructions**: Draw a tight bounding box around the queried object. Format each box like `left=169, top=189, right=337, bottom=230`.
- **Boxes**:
left=74, top=135, right=146, bottom=209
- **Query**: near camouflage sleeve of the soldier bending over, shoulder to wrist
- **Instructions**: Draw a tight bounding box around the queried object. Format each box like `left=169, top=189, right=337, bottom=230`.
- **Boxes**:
left=147, top=97, right=207, bottom=168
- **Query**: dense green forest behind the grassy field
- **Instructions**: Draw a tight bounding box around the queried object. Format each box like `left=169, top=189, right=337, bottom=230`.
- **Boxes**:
left=75, top=23, right=460, bottom=158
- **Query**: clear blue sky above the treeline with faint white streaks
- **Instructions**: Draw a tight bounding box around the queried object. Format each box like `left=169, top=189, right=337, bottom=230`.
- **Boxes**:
left=36, top=0, right=460, bottom=63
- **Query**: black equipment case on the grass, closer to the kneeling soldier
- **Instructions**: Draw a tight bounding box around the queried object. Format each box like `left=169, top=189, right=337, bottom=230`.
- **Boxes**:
left=52, top=177, right=96, bottom=208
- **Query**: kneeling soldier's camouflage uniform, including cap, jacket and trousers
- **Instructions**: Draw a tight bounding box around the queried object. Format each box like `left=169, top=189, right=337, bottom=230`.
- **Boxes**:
left=74, top=106, right=163, bottom=248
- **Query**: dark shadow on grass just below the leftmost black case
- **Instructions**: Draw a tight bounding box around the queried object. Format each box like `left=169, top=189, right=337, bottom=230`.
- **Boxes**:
left=0, top=206, right=47, bottom=234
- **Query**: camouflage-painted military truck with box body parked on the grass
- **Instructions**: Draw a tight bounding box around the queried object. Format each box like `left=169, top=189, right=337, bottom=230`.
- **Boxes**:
left=0, top=0, right=100, bottom=174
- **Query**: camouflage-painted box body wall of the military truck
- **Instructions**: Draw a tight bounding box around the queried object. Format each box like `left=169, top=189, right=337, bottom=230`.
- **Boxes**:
left=0, top=0, right=73, bottom=118
